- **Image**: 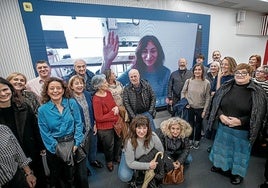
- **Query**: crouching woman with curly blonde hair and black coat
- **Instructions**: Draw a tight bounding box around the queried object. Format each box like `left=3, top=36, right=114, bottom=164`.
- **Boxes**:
left=156, top=117, right=192, bottom=172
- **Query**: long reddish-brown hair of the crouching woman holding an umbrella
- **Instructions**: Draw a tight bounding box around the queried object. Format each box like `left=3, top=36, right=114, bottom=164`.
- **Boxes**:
left=126, top=115, right=152, bottom=149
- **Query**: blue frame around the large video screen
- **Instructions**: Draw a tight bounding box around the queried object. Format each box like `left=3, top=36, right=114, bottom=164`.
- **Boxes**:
left=19, top=0, right=210, bottom=74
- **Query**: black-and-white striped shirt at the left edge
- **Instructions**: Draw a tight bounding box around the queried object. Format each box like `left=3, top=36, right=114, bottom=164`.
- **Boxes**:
left=0, top=124, right=31, bottom=184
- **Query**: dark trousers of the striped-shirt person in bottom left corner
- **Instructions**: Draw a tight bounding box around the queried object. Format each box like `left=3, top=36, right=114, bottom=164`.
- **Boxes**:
left=2, top=168, right=29, bottom=188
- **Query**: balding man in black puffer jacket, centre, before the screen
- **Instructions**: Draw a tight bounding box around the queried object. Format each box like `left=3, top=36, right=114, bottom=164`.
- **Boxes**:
left=123, top=69, right=156, bottom=131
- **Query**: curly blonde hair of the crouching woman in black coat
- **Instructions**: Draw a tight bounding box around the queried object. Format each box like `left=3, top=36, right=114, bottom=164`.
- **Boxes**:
left=160, top=117, right=193, bottom=139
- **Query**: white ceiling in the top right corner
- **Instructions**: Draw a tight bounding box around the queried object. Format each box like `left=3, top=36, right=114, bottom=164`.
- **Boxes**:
left=184, top=0, right=268, bottom=14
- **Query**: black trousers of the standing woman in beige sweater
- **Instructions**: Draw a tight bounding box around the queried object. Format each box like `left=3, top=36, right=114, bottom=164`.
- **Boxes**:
left=188, top=108, right=203, bottom=141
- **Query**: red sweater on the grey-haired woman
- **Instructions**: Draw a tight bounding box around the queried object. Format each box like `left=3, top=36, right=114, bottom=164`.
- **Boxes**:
left=93, top=91, right=118, bottom=130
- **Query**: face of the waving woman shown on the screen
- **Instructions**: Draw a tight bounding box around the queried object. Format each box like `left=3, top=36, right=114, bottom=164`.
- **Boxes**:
left=141, top=42, right=158, bottom=67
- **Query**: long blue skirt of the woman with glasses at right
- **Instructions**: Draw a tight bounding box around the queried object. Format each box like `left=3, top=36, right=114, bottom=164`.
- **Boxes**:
left=209, top=123, right=251, bottom=177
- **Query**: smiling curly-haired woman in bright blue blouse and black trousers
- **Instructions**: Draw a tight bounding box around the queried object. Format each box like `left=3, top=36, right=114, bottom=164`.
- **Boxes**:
left=38, top=77, right=86, bottom=188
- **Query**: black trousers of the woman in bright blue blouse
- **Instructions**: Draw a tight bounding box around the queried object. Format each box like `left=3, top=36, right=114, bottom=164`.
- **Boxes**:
left=47, top=151, right=74, bottom=188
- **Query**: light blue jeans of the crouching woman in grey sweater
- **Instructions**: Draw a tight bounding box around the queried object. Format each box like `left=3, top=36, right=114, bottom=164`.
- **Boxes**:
left=118, top=152, right=134, bottom=182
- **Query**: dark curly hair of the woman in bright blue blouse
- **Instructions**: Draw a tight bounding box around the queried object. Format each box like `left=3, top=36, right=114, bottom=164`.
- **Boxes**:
left=41, top=77, right=71, bottom=104
